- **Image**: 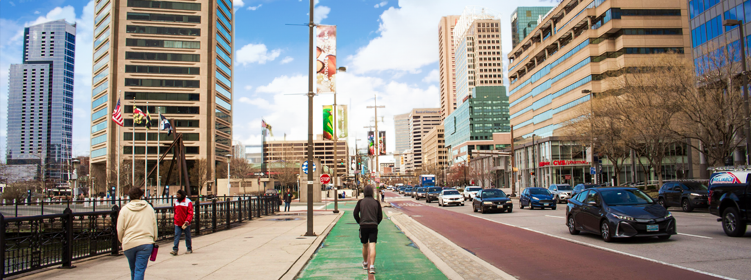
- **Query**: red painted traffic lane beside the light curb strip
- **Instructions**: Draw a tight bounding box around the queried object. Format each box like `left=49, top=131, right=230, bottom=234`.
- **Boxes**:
left=395, top=201, right=717, bottom=280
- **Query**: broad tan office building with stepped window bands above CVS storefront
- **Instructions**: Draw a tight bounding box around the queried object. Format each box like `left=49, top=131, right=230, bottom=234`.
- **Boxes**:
left=508, top=0, right=692, bottom=187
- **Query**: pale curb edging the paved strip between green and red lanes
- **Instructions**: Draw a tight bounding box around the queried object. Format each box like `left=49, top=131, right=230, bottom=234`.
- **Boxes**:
left=391, top=212, right=517, bottom=280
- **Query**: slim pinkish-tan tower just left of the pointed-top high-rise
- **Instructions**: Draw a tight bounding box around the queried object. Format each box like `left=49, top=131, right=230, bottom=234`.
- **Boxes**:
left=438, top=16, right=459, bottom=120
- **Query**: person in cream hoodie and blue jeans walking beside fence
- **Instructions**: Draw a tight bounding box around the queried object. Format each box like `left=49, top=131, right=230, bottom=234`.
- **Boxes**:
left=117, top=187, right=158, bottom=280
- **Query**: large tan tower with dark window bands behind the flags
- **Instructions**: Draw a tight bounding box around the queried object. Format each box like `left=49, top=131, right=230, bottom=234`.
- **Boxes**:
left=91, top=0, right=235, bottom=190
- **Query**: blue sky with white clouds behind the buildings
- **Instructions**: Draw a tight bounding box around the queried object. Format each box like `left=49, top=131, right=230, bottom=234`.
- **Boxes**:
left=0, top=0, right=557, bottom=161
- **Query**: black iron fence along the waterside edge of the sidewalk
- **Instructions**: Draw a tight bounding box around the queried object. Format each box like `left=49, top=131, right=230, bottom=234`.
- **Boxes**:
left=0, top=196, right=279, bottom=279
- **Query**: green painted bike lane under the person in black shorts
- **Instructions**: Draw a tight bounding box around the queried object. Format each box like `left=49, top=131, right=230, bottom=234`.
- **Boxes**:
left=299, top=201, right=447, bottom=280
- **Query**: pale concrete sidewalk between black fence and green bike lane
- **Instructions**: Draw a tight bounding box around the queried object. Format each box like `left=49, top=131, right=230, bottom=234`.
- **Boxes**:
left=16, top=212, right=340, bottom=280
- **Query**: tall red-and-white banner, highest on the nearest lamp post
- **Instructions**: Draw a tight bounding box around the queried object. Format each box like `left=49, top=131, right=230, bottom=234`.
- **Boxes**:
left=315, top=25, right=336, bottom=93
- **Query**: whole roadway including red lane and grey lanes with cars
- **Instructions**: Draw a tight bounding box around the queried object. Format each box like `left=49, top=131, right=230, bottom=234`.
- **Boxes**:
left=387, top=193, right=751, bottom=279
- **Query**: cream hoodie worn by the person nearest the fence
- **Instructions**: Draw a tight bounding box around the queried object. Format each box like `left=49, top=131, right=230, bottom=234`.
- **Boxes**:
left=117, top=199, right=158, bottom=251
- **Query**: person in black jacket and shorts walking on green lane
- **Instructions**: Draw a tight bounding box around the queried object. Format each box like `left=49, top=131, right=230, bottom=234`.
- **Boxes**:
left=353, top=185, right=383, bottom=274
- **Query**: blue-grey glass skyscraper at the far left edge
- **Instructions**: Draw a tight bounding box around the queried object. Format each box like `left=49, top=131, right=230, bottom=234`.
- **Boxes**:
left=6, top=20, right=76, bottom=181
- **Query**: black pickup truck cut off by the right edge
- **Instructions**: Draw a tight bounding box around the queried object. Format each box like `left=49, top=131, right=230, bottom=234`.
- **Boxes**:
left=709, top=171, right=751, bottom=237
